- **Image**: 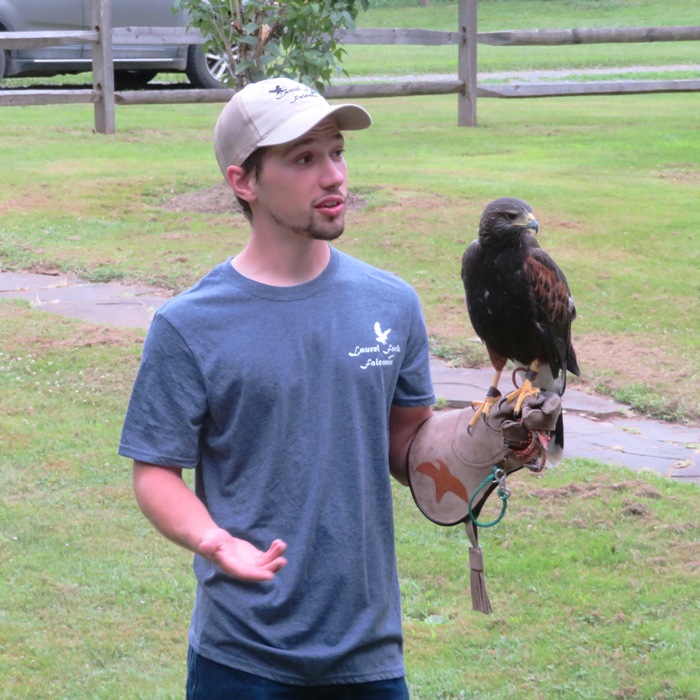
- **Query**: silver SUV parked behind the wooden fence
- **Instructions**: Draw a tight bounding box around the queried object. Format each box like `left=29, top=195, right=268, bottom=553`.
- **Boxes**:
left=0, top=0, right=226, bottom=89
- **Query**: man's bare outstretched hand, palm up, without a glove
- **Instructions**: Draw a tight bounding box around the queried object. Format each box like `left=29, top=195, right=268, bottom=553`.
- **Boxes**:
left=198, top=527, right=287, bottom=581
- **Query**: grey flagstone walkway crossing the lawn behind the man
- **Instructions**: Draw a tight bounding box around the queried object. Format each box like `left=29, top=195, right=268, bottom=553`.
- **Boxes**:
left=0, top=272, right=700, bottom=484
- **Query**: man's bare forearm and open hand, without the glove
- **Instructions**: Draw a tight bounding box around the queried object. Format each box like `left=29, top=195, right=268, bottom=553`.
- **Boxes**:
left=133, top=461, right=287, bottom=581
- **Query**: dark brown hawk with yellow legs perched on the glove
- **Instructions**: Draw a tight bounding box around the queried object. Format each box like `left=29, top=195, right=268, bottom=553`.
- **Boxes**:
left=462, top=197, right=580, bottom=462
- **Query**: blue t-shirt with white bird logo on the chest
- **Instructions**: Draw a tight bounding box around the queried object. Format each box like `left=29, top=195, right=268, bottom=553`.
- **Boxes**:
left=119, top=248, right=434, bottom=684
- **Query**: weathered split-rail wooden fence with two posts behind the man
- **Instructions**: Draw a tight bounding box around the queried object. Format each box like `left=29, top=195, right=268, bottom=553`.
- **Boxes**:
left=0, top=0, right=700, bottom=134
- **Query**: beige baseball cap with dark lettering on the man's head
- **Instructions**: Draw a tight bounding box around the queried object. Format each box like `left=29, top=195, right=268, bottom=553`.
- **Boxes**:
left=214, top=78, right=372, bottom=177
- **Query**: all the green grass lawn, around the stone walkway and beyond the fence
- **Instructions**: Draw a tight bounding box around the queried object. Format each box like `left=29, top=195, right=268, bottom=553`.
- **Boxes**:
left=0, top=0, right=700, bottom=700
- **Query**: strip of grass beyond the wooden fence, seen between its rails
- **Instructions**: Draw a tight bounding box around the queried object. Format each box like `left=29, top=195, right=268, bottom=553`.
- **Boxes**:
left=344, top=0, right=700, bottom=77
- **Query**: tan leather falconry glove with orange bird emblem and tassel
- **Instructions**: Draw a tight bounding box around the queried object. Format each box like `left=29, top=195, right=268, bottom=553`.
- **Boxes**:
left=406, top=391, right=561, bottom=612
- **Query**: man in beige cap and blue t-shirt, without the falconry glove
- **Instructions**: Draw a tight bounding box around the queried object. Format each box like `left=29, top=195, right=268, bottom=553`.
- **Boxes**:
left=119, top=78, right=434, bottom=700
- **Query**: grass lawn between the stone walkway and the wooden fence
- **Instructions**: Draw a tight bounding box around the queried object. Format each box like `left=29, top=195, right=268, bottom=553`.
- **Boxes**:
left=0, top=94, right=700, bottom=421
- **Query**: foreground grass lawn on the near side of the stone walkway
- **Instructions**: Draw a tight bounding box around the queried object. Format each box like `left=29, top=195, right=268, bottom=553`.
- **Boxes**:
left=0, top=302, right=700, bottom=700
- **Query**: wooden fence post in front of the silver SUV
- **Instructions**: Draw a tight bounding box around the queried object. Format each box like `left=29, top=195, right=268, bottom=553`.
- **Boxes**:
left=91, top=0, right=116, bottom=134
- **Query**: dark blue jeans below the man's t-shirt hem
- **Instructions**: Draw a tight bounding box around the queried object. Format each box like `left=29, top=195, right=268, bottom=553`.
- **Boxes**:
left=187, top=647, right=408, bottom=700
